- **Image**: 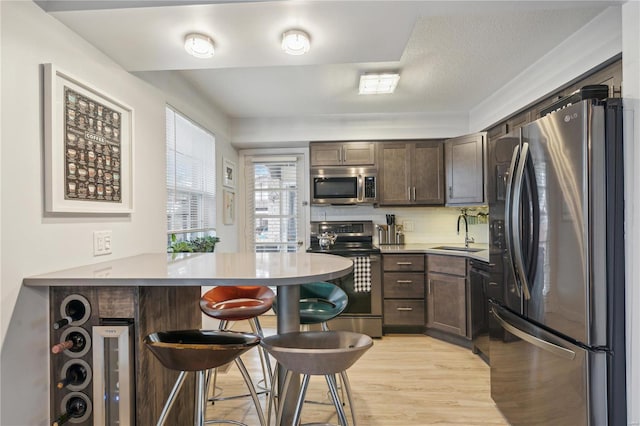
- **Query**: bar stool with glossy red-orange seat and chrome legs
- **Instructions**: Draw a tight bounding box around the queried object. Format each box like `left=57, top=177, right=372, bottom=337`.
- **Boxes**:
left=200, top=286, right=275, bottom=401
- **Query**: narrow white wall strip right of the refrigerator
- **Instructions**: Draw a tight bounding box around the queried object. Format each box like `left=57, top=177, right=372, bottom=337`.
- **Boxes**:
left=622, top=2, right=640, bottom=426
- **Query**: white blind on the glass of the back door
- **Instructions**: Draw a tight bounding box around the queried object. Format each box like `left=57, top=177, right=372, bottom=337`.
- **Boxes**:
left=245, top=156, right=303, bottom=252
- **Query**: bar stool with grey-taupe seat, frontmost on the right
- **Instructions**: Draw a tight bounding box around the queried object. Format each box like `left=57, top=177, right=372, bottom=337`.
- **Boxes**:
left=261, top=331, right=373, bottom=426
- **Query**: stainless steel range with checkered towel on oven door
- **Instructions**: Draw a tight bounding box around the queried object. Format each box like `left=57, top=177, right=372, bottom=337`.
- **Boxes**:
left=307, top=221, right=382, bottom=337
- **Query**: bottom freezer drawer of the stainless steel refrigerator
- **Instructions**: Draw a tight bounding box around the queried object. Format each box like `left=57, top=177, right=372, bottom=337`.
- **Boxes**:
left=490, top=303, right=608, bottom=426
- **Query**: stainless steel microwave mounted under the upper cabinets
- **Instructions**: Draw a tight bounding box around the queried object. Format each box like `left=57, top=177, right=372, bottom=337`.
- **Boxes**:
left=311, top=167, right=378, bottom=204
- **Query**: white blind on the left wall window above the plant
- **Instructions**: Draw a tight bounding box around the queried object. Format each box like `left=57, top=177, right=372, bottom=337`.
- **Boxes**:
left=167, top=107, right=216, bottom=239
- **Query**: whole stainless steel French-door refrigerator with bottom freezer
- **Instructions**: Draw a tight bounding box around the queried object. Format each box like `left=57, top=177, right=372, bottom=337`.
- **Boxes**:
left=488, top=99, right=626, bottom=426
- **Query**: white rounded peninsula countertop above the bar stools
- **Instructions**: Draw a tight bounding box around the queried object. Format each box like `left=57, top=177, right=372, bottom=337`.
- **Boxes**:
left=23, top=253, right=353, bottom=287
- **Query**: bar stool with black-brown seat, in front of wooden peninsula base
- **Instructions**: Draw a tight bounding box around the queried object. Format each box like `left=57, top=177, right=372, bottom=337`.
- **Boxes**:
left=144, top=330, right=265, bottom=426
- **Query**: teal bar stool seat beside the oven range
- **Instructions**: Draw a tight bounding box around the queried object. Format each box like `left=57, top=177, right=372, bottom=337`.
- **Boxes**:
left=273, top=281, right=349, bottom=331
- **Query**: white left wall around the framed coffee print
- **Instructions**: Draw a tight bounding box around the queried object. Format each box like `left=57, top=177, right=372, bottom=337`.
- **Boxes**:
left=0, top=1, right=235, bottom=426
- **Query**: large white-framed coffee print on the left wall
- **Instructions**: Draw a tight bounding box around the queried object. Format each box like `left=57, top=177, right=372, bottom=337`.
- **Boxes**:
left=44, top=64, right=133, bottom=213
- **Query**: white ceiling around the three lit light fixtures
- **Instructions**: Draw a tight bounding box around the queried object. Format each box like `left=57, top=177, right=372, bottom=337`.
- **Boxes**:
left=37, top=0, right=620, bottom=118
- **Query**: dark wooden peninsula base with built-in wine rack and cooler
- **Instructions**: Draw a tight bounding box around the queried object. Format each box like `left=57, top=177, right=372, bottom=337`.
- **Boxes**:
left=49, top=286, right=202, bottom=426
